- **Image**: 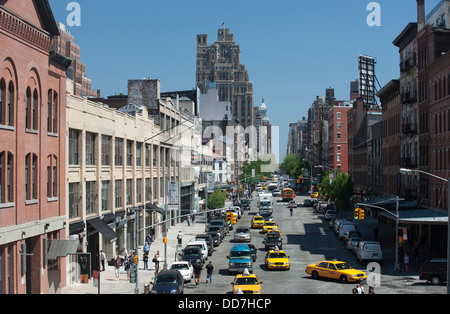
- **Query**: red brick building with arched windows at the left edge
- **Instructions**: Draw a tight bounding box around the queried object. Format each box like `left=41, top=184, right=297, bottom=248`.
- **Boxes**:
left=0, top=0, right=70, bottom=294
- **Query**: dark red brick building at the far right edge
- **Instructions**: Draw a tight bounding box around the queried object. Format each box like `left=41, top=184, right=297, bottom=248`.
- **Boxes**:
left=418, top=26, right=450, bottom=210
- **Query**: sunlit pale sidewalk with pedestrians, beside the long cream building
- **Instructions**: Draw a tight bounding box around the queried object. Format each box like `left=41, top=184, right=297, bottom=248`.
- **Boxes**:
left=61, top=217, right=205, bottom=294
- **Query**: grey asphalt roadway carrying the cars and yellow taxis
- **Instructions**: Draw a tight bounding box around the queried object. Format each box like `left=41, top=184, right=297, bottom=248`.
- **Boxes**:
left=185, top=196, right=445, bottom=294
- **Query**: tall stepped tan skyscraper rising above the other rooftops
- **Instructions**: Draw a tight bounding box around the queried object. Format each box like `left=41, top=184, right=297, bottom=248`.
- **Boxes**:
left=196, top=28, right=254, bottom=128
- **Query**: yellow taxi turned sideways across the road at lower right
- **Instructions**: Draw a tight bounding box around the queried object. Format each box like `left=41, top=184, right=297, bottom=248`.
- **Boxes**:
left=305, top=261, right=367, bottom=283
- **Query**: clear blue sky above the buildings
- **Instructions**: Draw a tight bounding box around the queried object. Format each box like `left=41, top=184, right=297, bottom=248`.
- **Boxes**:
left=50, top=0, right=439, bottom=159
